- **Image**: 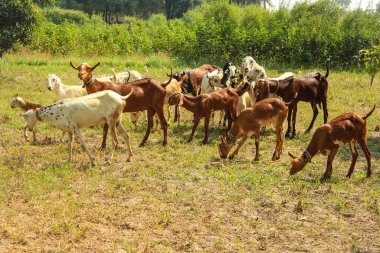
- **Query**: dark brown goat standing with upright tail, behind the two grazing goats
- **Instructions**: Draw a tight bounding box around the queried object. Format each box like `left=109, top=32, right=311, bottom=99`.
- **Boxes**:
left=255, top=68, right=329, bottom=138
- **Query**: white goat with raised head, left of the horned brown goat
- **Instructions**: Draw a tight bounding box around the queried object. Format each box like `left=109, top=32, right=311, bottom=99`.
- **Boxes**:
left=46, top=74, right=87, bottom=99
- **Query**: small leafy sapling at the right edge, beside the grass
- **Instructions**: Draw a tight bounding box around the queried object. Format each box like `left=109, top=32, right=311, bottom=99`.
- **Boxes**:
left=359, top=44, right=380, bottom=86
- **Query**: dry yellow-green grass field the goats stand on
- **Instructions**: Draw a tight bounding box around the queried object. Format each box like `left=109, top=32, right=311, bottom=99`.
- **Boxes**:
left=0, top=53, right=380, bottom=253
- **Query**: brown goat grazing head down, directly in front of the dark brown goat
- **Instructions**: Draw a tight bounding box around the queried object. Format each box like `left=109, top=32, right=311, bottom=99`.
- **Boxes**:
left=219, top=98, right=290, bottom=161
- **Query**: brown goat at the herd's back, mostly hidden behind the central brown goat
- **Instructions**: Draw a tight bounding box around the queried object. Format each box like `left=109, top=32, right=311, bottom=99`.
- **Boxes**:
left=173, top=64, right=218, bottom=96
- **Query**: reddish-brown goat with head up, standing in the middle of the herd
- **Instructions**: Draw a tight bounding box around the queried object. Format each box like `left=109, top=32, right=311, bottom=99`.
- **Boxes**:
left=169, top=83, right=249, bottom=144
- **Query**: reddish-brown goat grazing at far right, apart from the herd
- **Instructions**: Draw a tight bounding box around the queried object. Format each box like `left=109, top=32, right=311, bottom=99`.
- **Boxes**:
left=289, top=106, right=376, bottom=180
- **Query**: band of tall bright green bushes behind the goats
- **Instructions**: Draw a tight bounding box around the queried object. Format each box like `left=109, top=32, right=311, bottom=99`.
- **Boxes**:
left=23, top=0, right=380, bottom=67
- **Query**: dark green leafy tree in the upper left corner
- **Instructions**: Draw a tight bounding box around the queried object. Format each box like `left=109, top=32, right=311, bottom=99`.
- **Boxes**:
left=0, top=0, right=52, bottom=58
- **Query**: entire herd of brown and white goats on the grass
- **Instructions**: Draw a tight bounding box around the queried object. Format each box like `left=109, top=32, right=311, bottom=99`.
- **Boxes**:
left=11, top=56, right=375, bottom=180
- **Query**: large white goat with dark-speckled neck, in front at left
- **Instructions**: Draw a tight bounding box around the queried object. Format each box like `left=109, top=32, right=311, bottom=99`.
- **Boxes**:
left=22, top=90, right=133, bottom=165
